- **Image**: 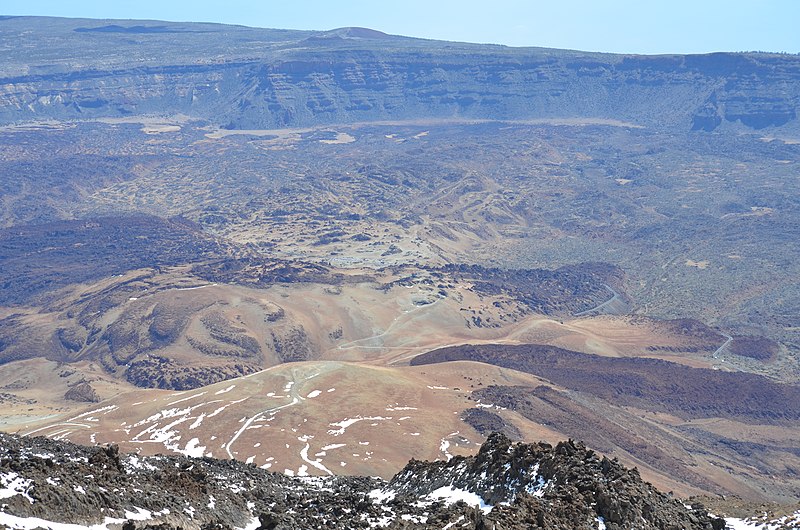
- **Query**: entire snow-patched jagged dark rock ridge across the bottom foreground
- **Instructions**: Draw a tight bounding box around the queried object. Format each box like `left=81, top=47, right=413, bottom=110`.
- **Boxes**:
left=0, top=433, right=725, bottom=530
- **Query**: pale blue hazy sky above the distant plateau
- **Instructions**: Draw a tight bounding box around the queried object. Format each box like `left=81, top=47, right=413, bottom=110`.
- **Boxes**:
left=0, top=0, right=800, bottom=53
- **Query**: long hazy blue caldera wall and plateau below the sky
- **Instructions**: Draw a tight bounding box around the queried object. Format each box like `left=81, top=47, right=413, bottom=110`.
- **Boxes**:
left=0, top=18, right=800, bottom=131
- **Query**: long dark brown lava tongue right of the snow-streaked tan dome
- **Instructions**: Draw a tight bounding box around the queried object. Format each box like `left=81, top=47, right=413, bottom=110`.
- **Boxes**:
left=411, top=344, right=800, bottom=422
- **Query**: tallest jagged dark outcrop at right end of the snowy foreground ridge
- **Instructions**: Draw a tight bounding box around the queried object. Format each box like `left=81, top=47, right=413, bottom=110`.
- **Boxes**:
left=389, top=433, right=725, bottom=530
